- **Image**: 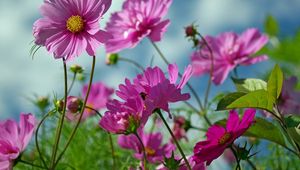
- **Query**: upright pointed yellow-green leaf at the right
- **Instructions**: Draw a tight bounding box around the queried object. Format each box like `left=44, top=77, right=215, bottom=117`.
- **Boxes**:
left=267, top=64, right=283, bottom=99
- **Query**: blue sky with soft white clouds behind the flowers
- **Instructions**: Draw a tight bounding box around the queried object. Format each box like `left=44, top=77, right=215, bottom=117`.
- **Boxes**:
left=0, top=0, right=300, bottom=119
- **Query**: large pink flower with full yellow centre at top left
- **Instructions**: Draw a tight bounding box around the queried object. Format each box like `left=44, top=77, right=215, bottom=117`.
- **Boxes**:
left=33, top=0, right=111, bottom=60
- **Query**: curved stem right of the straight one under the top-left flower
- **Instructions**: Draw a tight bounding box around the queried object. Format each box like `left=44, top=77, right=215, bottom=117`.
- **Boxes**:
left=53, top=56, right=96, bottom=168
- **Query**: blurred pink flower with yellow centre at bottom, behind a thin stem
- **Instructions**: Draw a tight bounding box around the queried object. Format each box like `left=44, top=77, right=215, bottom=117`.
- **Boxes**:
left=118, top=129, right=175, bottom=163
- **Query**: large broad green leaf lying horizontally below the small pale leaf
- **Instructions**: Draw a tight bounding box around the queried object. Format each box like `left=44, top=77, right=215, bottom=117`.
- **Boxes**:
left=217, top=90, right=276, bottom=112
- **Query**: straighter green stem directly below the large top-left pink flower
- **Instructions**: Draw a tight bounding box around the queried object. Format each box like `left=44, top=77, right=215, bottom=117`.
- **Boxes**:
left=50, top=58, right=68, bottom=169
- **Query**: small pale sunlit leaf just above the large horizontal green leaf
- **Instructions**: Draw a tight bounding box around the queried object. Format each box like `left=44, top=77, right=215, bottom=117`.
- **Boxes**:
left=232, top=78, right=267, bottom=93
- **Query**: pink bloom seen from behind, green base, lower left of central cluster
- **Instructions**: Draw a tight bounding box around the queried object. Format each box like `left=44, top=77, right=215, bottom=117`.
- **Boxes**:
left=99, top=96, right=148, bottom=134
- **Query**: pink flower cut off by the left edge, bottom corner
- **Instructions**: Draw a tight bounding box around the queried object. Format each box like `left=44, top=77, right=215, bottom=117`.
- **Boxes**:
left=0, top=113, right=35, bottom=170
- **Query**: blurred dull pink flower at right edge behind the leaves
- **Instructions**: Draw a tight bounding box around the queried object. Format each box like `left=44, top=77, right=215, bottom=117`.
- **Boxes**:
left=279, top=77, right=300, bottom=114
